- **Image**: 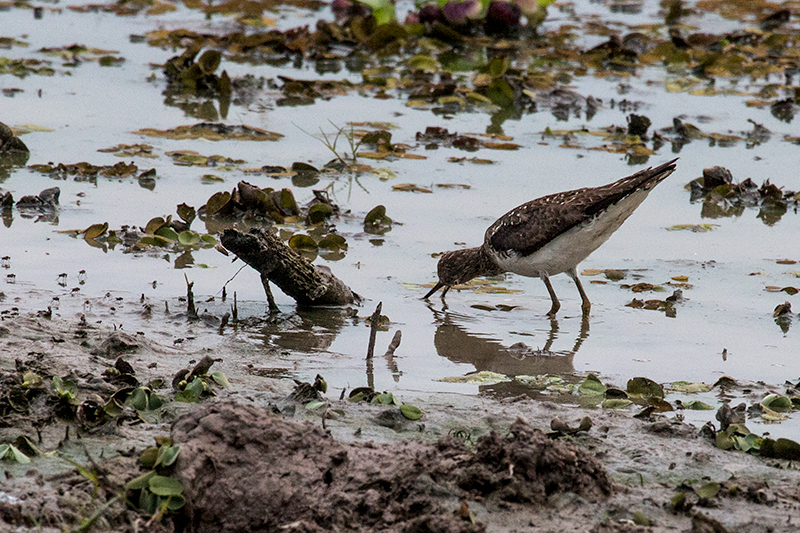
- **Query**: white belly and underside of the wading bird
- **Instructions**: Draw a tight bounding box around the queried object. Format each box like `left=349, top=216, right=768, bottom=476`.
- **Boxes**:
left=493, top=190, right=649, bottom=278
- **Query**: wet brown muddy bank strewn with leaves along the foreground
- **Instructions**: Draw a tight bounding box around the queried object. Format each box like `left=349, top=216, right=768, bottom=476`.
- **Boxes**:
left=0, top=308, right=800, bottom=533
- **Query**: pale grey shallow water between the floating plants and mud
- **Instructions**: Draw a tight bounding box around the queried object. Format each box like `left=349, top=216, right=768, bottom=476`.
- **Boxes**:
left=0, top=2, right=800, bottom=432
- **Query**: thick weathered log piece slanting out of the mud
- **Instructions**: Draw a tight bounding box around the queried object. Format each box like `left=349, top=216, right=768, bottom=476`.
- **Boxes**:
left=222, top=228, right=360, bottom=306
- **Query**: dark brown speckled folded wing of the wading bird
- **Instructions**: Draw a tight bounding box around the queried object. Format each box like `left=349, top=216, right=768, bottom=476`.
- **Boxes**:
left=484, top=159, right=677, bottom=256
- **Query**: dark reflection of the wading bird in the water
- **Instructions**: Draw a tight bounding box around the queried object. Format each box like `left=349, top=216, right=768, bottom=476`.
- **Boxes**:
left=428, top=304, right=589, bottom=397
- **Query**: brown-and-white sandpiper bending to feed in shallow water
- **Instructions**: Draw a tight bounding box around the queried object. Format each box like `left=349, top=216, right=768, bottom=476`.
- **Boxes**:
left=424, top=159, right=677, bottom=317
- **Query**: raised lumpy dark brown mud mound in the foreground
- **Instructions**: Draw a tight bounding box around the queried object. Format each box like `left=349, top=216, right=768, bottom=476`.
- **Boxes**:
left=172, top=403, right=611, bottom=533
